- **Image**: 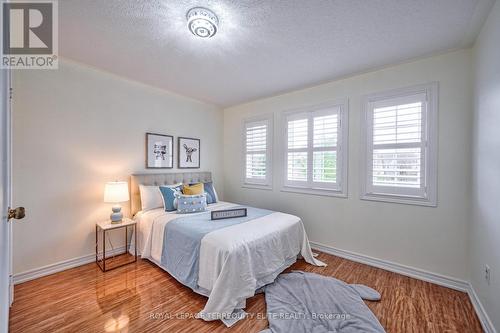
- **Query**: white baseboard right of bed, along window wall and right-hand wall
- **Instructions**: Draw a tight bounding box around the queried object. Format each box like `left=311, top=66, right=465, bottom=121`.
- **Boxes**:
left=310, top=242, right=497, bottom=333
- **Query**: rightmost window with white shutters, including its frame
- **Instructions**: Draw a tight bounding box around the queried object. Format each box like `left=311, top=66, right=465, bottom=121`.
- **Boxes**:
left=362, top=84, right=437, bottom=206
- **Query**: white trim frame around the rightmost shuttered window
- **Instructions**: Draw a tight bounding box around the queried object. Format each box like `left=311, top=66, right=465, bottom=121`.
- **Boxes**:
left=360, top=82, right=439, bottom=207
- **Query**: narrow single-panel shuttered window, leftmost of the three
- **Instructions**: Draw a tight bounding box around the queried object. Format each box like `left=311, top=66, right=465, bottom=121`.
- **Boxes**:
left=243, top=117, right=272, bottom=188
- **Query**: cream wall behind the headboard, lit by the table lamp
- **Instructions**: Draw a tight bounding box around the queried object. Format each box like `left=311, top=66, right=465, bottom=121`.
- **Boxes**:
left=13, top=60, right=223, bottom=273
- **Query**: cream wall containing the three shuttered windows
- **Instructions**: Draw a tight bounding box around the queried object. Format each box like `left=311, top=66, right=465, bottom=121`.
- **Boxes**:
left=224, top=50, right=472, bottom=279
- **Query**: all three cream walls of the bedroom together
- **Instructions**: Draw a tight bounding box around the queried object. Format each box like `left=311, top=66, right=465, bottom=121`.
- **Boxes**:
left=9, top=20, right=500, bottom=329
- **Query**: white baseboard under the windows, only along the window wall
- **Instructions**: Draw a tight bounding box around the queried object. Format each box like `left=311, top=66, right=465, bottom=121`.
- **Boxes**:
left=310, top=242, right=469, bottom=292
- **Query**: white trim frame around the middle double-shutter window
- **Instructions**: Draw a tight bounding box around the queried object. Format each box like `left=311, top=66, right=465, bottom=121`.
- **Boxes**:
left=280, top=98, right=349, bottom=198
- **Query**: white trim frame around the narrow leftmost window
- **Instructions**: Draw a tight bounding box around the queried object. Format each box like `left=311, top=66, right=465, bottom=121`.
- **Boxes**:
left=241, top=114, right=274, bottom=190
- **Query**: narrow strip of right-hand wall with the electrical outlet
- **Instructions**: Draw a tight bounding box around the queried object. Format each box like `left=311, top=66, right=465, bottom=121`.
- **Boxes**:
left=470, top=1, right=500, bottom=331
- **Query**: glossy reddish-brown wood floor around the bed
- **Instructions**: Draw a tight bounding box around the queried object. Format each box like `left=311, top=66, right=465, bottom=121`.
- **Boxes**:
left=10, top=253, right=482, bottom=333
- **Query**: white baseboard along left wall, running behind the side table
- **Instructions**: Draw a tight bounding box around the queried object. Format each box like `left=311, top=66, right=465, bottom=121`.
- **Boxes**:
left=12, top=246, right=125, bottom=284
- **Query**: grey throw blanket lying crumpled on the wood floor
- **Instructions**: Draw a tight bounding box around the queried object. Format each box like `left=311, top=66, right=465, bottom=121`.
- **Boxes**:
left=261, top=271, right=385, bottom=333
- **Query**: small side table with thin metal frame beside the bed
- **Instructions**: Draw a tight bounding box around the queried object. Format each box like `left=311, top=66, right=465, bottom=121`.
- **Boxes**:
left=95, top=218, right=137, bottom=272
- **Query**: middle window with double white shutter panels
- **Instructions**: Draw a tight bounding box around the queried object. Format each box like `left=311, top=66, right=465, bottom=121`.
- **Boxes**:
left=283, top=102, right=347, bottom=197
